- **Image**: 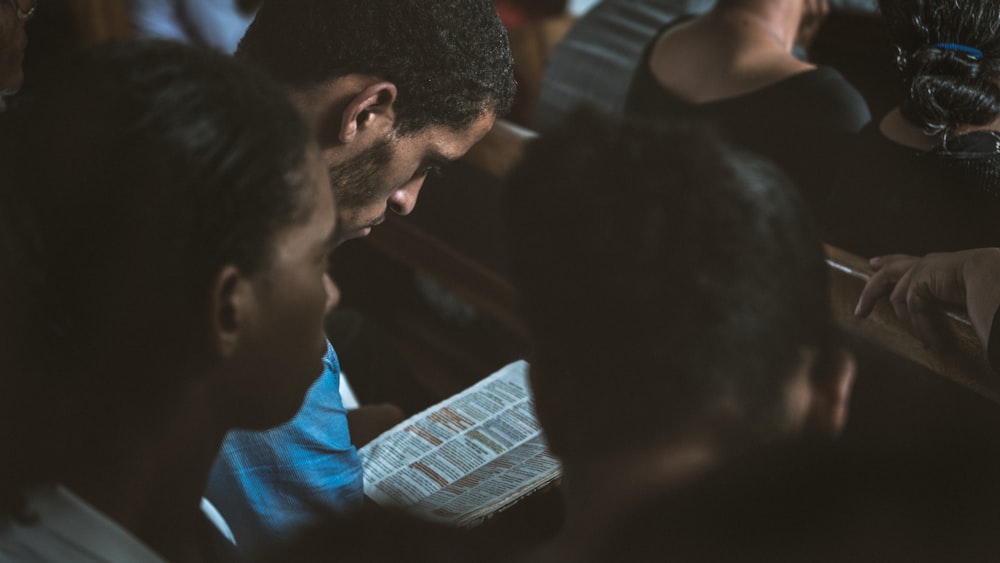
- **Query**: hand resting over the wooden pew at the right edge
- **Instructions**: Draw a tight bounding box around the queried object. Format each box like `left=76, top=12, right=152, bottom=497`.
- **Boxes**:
left=855, top=248, right=1000, bottom=349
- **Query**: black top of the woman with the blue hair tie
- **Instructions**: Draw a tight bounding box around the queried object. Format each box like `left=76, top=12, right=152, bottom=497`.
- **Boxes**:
left=821, top=123, right=1000, bottom=256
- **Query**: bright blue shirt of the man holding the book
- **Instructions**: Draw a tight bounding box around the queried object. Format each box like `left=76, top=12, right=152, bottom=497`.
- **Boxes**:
left=205, top=342, right=364, bottom=551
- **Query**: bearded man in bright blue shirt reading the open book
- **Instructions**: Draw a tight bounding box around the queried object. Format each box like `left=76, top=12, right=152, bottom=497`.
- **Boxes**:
left=207, top=0, right=515, bottom=549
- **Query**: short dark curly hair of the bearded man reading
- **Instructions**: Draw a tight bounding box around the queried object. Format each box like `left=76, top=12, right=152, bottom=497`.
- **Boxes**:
left=236, top=0, right=516, bottom=134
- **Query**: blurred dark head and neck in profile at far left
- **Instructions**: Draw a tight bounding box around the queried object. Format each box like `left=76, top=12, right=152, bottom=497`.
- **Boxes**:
left=0, top=42, right=336, bottom=560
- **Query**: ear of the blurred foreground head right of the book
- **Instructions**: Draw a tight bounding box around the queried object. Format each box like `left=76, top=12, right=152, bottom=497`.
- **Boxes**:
left=806, top=347, right=857, bottom=438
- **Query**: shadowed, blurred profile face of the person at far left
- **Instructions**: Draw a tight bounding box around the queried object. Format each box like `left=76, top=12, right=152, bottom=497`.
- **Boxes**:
left=232, top=150, right=339, bottom=427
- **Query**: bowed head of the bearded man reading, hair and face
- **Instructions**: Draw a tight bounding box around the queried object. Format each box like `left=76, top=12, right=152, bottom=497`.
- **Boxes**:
left=237, top=0, right=515, bottom=239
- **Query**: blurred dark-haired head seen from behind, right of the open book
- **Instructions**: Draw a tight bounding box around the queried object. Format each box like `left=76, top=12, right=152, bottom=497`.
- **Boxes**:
left=507, top=108, right=853, bottom=560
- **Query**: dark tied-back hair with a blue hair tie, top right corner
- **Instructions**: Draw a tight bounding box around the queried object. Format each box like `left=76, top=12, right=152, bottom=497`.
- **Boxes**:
left=879, top=0, right=1000, bottom=133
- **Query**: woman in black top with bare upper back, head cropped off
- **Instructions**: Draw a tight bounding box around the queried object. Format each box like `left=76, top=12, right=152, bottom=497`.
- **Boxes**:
left=625, top=0, right=871, bottom=212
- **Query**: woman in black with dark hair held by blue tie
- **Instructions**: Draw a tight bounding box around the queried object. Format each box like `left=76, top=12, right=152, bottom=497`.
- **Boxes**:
left=822, top=0, right=1000, bottom=256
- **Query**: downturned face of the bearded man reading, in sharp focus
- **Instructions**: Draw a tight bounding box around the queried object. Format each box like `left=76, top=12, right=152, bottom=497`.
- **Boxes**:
left=324, top=113, right=496, bottom=240
